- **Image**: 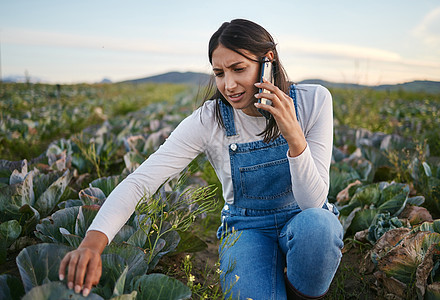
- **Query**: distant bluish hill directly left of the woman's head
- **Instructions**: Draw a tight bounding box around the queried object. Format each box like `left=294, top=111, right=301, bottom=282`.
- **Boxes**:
left=119, top=72, right=211, bottom=85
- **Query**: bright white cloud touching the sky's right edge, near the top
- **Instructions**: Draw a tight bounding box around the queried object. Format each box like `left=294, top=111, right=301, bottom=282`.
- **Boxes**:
left=411, top=6, right=440, bottom=46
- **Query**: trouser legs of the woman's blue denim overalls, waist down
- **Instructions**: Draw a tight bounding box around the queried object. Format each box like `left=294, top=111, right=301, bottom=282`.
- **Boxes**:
left=218, top=205, right=343, bottom=300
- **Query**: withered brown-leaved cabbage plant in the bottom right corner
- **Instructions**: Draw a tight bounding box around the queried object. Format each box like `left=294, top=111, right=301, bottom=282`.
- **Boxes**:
left=367, top=220, right=440, bottom=299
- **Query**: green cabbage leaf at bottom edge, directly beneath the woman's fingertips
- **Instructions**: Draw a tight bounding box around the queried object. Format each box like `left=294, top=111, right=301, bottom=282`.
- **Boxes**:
left=23, top=282, right=103, bottom=300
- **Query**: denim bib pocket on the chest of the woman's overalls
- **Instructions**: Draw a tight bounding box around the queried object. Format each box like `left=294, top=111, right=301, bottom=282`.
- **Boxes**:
left=239, top=158, right=292, bottom=200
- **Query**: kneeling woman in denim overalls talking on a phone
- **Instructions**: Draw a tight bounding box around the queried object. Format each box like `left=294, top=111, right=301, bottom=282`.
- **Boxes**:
left=59, top=19, right=343, bottom=300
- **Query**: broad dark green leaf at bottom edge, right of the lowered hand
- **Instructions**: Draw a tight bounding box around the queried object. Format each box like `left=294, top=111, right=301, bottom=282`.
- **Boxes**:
left=132, top=274, right=191, bottom=300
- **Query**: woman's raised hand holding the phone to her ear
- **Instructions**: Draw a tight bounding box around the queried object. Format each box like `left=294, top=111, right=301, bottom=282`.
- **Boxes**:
left=255, top=80, right=307, bottom=157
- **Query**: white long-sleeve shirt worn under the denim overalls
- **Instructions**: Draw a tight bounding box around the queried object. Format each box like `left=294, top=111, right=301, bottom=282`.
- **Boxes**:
left=88, top=84, right=333, bottom=242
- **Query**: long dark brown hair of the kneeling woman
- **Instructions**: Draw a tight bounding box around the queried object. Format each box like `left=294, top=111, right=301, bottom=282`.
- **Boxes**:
left=204, top=19, right=289, bottom=143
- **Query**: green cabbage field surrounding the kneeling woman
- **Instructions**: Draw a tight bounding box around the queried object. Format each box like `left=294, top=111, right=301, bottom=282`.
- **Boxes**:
left=0, top=83, right=440, bottom=299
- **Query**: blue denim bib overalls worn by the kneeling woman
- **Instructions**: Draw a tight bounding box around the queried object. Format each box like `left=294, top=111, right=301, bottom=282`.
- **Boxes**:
left=217, top=85, right=343, bottom=300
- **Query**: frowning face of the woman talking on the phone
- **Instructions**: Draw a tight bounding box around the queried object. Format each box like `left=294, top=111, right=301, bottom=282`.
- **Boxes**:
left=212, top=44, right=261, bottom=116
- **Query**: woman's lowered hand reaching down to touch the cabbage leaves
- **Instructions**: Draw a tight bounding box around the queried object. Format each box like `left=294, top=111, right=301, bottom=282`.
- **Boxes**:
left=59, top=230, right=108, bottom=297
